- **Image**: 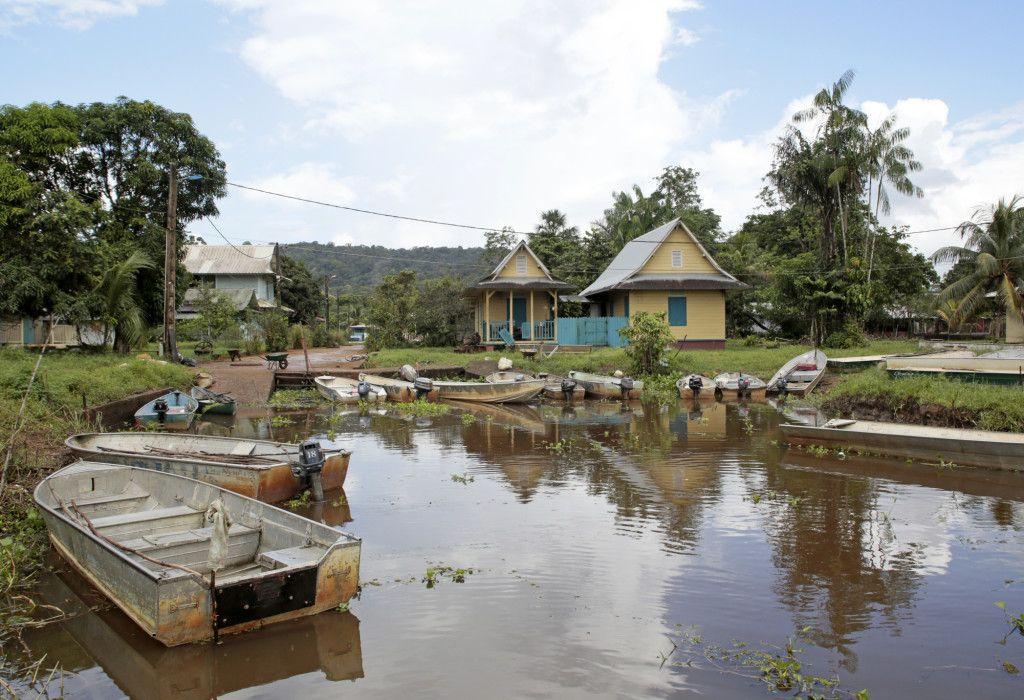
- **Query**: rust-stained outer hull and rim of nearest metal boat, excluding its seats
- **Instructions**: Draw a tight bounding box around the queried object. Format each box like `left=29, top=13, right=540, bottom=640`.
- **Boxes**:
left=35, top=463, right=360, bottom=647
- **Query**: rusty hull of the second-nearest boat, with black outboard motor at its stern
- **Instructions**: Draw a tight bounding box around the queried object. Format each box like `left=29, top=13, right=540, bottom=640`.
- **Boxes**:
left=65, top=435, right=351, bottom=504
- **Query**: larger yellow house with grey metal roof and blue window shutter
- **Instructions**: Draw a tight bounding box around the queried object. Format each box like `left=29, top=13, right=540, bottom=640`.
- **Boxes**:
left=580, top=219, right=746, bottom=349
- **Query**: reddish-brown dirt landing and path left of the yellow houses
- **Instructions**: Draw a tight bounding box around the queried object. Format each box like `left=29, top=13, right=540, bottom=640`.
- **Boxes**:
left=199, top=345, right=366, bottom=405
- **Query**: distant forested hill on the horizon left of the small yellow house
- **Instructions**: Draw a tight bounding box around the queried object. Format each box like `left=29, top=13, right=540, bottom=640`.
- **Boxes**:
left=282, top=243, right=487, bottom=289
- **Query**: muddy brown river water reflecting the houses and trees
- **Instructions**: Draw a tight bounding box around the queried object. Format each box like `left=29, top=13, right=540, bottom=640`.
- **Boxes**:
left=6, top=402, right=1024, bottom=698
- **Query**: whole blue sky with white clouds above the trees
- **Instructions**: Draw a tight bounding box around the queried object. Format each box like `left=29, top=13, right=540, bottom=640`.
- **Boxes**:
left=0, top=0, right=1024, bottom=253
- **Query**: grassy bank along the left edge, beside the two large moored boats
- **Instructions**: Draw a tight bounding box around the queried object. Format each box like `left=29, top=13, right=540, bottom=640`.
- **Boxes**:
left=0, top=349, right=191, bottom=601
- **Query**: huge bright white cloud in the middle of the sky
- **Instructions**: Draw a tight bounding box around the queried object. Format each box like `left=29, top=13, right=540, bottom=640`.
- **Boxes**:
left=216, top=0, right=735, bottom=245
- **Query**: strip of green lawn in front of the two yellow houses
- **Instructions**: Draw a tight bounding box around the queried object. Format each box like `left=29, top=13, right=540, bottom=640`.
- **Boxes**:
left=368, top=341, right=918, bottom=380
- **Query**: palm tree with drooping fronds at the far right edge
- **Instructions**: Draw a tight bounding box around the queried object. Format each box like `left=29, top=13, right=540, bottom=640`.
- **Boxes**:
left=932, top=194, right=1024, bottom=321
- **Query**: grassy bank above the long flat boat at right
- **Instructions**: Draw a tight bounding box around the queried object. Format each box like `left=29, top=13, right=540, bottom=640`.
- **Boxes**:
left=818, top=368, right=1024, bottom=433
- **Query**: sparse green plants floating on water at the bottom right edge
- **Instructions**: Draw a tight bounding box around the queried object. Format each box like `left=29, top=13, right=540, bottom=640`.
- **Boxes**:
left=658, top=627, right=870, bottom=700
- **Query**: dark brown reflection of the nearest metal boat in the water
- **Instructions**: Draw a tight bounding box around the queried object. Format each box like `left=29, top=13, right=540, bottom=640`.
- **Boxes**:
left=25, top=571, right=362, bottom=700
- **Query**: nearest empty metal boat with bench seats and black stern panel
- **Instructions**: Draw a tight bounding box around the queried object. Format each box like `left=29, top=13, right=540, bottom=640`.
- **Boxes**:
left=35, top=462, right=360, bottom=647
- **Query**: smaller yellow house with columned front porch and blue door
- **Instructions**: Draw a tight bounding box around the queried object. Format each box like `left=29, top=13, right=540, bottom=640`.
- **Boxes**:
left=470, top=242, right=571, bottom=345
